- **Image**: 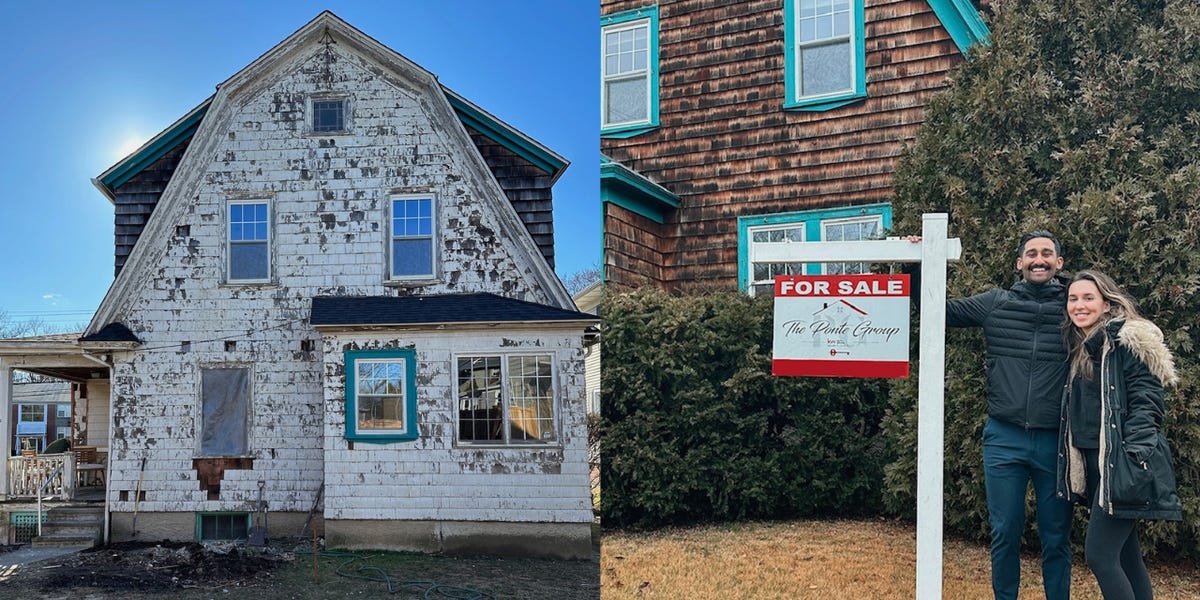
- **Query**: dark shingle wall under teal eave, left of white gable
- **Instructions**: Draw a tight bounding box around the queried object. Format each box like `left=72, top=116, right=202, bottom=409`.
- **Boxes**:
left=113, top=140, right=191, bottom=275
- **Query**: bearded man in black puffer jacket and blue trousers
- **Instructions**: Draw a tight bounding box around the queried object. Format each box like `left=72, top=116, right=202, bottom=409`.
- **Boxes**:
left=946, top=230, right=1072, bottom=600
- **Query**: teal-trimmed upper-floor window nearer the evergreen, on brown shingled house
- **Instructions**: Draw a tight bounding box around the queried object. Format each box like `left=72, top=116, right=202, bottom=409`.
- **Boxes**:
left=784, top=0, right=866, bottom=110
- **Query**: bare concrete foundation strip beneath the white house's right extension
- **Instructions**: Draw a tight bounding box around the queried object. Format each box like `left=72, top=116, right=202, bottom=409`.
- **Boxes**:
left=325, top=520, right=592, bottom=559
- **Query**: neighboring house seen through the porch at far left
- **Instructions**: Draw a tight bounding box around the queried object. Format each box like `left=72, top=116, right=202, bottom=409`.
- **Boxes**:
left=8, top=382, right=74, bottom=455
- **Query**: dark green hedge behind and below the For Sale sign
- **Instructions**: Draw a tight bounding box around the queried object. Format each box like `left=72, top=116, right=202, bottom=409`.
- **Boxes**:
left=601, top=290, right=887, bottom=527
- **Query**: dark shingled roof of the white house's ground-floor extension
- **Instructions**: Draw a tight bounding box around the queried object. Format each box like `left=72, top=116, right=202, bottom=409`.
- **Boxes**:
left=311, top=293, right=599, bottom=329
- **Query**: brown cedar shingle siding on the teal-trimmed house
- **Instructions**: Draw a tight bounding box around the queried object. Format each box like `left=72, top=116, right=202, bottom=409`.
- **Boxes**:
left=601, top=0, right=962, bottom=288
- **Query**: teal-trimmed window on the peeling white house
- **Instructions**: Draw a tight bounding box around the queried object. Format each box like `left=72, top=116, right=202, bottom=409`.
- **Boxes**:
left=346, top=348, right=419, bottom=443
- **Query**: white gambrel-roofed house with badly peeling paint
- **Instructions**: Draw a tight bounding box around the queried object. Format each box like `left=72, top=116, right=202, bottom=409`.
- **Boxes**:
left=0, top=12, right=598, bottom=558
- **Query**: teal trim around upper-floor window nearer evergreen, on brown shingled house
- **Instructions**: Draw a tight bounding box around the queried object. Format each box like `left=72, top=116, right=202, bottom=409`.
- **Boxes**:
left=784, top=0, right=866, bottom=110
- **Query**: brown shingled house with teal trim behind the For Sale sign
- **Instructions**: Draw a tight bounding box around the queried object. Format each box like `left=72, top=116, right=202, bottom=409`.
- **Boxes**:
left=600, top=0, right=988, bottom=294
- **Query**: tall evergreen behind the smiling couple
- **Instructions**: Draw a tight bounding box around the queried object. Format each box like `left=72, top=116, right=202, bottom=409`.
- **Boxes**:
left=887, top=0, right=1200, bottom=557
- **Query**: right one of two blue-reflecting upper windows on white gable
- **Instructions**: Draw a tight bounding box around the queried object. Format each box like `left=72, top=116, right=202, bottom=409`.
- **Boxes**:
left=388, top=196, right=437, bottom=280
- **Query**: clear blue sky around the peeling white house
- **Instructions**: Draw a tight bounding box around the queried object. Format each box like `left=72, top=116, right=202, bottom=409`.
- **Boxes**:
left=0, top=0, right=600, bottom=328
